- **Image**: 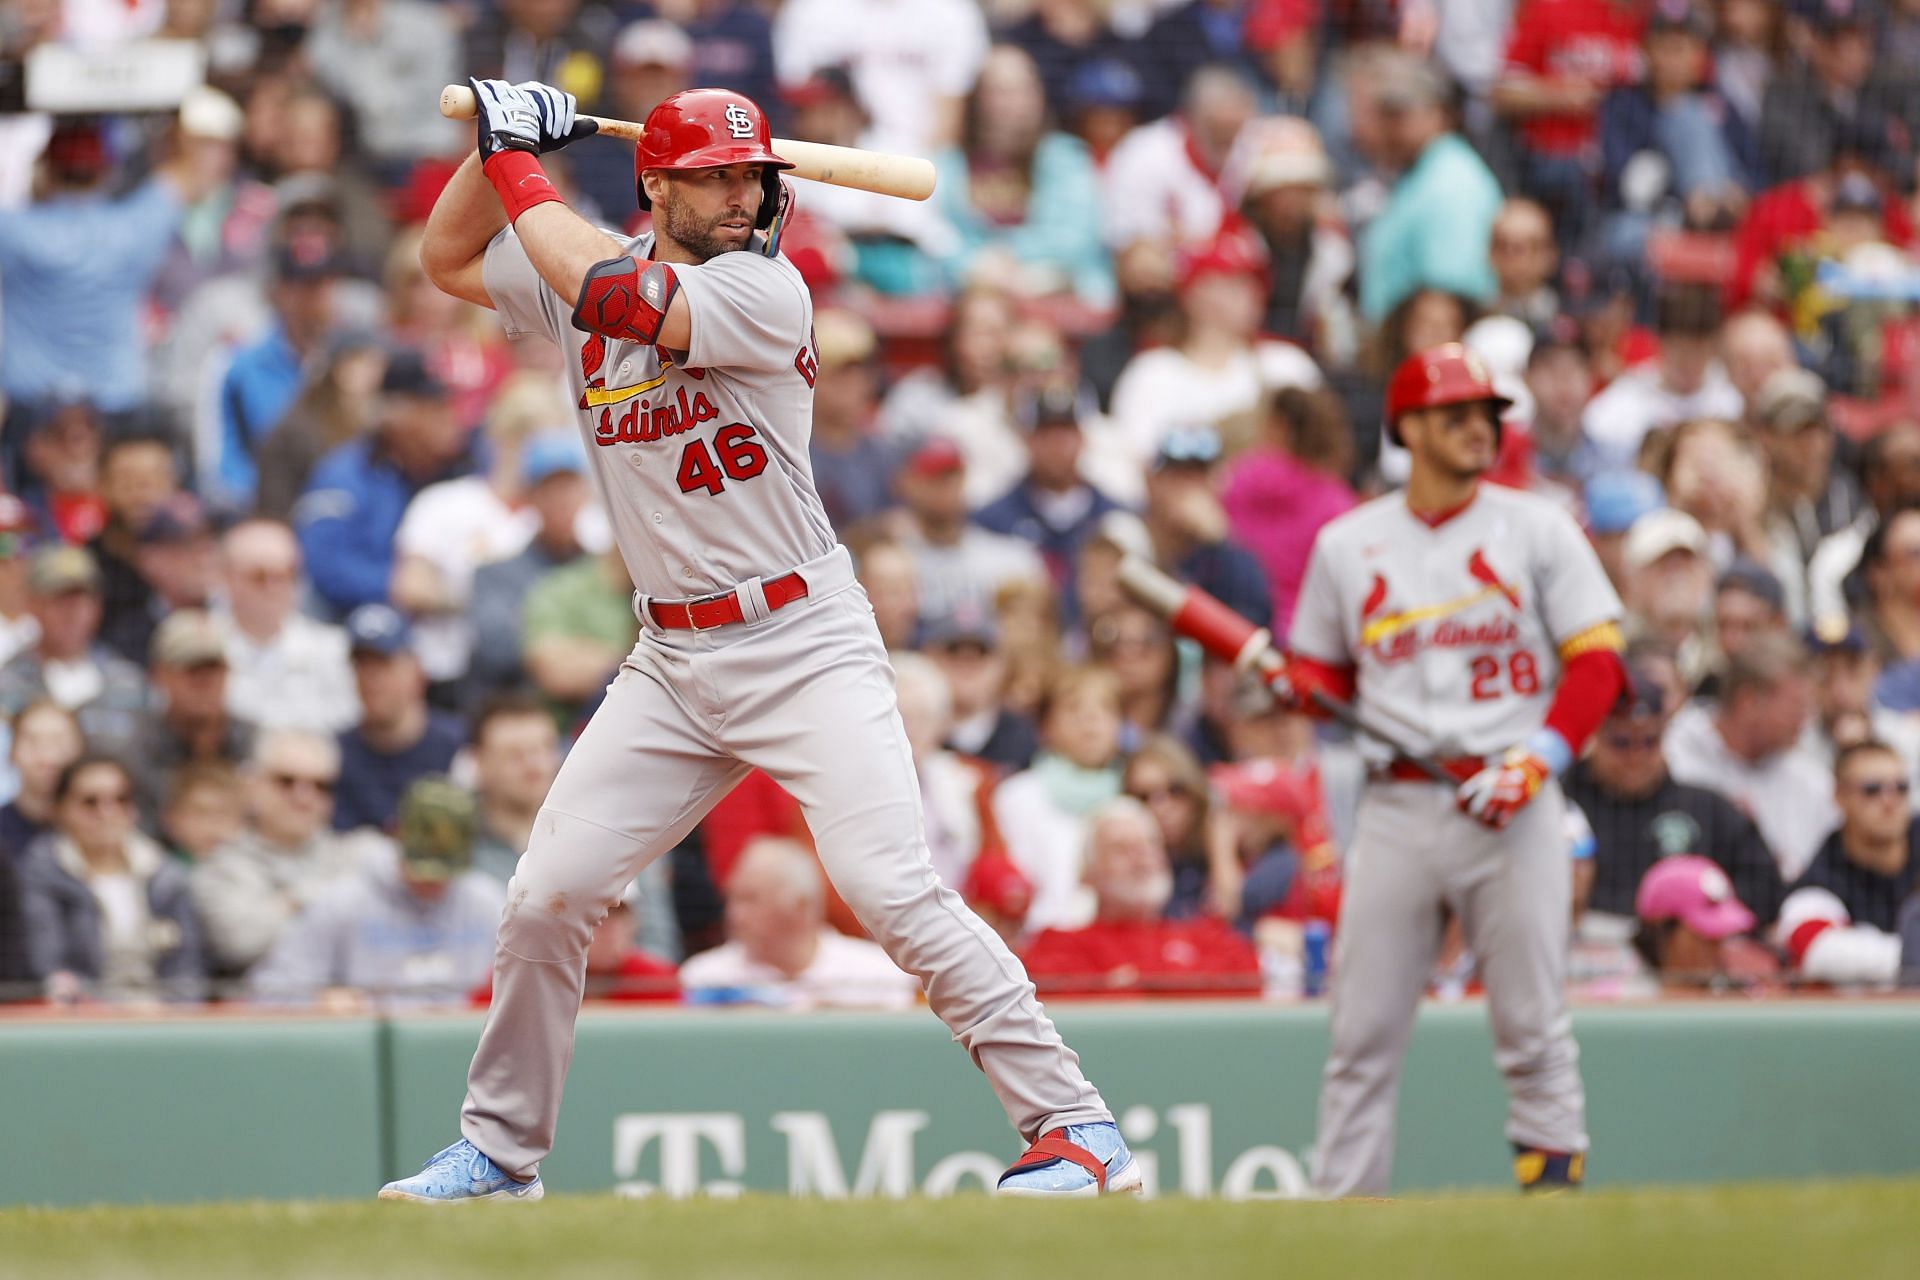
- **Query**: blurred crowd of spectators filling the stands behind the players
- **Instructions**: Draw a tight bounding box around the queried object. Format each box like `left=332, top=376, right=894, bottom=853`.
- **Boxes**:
left=0, top=0, right=1920, bottom=1007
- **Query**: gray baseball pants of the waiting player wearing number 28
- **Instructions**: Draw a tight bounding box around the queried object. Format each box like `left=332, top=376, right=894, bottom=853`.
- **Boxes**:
left=1313, top=781, right=1586, bottom=1196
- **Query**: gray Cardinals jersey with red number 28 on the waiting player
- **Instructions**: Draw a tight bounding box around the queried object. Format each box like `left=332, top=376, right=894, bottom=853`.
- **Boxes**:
left=1290, top=486, right=1620, bottom=756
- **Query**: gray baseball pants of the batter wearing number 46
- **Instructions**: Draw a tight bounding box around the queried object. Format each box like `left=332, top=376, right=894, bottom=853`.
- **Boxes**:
left=461, top=547, right=1112, bottom=1178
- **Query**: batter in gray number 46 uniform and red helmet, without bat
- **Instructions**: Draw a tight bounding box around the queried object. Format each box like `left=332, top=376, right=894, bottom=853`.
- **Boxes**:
left=380, top=81, right=1140, bottom=1203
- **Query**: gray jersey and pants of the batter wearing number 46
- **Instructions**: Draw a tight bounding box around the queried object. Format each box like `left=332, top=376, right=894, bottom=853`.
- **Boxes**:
left=461, top=230, right=1112, bottom=1176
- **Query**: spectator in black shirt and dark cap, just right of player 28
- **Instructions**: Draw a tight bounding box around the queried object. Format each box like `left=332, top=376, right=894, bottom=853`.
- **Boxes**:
left=1563, top=672, right=1784, bottom=929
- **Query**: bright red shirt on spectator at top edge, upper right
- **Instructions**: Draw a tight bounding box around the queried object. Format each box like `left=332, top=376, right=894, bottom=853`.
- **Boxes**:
left=1507, top=0, right=1645, bottom=155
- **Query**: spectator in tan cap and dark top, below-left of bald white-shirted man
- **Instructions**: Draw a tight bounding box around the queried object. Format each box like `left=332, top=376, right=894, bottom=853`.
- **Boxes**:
left=131, top=608, right=253, bottom=821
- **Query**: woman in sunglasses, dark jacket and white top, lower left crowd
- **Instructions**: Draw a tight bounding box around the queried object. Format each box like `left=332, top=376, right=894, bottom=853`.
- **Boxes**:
left=21, top=756, right=205, bottom=1000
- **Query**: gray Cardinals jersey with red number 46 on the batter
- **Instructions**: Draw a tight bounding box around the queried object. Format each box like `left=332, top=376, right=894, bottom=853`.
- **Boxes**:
left=484, top=226, right=833, bottom=599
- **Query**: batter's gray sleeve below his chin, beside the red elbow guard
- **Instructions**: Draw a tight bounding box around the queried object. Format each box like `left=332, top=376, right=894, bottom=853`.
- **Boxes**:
left=674, top=249, right=812, bottom=372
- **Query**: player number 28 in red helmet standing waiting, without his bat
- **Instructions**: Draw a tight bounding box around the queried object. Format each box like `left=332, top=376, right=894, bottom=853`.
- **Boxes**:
left=1286, top=344, right=1624, bottom=1196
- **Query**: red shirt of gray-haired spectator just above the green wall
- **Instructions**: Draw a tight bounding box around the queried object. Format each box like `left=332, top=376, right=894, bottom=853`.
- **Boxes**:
left=1021, top=917, right=1260, bottom=996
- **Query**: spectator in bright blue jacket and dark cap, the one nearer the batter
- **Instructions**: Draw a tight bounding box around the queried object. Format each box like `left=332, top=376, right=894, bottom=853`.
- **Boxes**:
left=294, top=349, right=483, bottom=612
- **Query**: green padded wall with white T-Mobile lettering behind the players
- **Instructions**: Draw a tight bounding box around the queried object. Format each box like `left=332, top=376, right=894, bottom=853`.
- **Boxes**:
left=0, top=1004, right=1920, bottom=1203
